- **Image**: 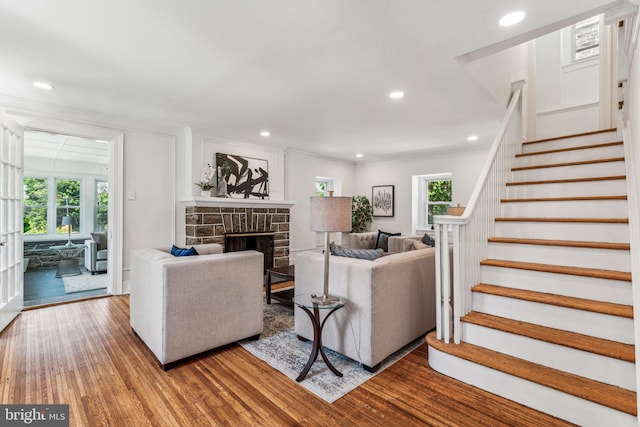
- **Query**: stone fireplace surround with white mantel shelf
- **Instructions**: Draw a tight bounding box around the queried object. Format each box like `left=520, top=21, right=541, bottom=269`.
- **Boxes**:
left=182, top=197, right=293, bottom=267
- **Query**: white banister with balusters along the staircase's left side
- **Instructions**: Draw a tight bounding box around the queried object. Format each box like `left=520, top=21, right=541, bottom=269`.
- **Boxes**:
left=433, top=82, right=524, bottom=344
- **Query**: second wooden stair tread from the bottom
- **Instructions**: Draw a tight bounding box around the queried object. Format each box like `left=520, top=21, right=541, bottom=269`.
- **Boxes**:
left=460, top=311, right=636, bottom=363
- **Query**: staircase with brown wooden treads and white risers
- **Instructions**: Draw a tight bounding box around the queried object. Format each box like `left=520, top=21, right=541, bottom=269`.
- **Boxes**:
left=427, top=130, right=638, bottom=426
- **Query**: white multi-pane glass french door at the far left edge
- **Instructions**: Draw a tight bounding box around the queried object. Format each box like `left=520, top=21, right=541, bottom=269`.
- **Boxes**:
left=0, top=113, right=24, bottom=331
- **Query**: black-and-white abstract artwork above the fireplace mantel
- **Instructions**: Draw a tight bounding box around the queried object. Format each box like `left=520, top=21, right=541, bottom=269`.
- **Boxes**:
left=215, top=153, right=269, bottom=200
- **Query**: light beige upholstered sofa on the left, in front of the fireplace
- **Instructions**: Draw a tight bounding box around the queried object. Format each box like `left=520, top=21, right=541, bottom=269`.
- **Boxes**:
left=130, top=244, right=264, bottom=369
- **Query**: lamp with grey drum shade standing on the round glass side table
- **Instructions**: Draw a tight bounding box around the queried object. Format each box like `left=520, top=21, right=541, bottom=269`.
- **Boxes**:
left=309, top=197, right=351, bottom=305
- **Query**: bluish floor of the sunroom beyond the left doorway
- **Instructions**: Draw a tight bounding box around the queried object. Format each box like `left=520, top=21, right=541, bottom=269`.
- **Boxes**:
left=24, top=267, right=107, bottom=307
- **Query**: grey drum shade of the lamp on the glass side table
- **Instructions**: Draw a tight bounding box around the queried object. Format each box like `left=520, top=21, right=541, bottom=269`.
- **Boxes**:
left=309, top=197, right=351, bottom=231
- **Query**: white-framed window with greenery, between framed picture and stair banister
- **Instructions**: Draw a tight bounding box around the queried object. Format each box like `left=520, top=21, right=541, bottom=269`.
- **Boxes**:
left=412, top=173, right=453, bottom=231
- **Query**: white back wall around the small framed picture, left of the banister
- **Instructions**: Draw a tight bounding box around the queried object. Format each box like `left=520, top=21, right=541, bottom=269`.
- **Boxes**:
left=354, top=147, right=489, bottom=234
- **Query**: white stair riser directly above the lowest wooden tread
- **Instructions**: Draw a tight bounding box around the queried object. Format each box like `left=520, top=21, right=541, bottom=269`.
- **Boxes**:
left=462, top=322, right=636, bottom=391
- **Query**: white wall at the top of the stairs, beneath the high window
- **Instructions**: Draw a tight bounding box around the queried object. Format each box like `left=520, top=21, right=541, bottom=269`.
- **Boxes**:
left=536, top=30, right=599, bottom=139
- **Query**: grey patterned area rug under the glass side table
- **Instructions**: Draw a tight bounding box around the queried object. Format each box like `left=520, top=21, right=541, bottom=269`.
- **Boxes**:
left=240, top=304, right=424, bottom=403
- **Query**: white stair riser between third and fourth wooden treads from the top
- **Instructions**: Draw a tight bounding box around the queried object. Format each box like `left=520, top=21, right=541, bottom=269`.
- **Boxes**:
left=512, top=161, right=624, bottom=181
